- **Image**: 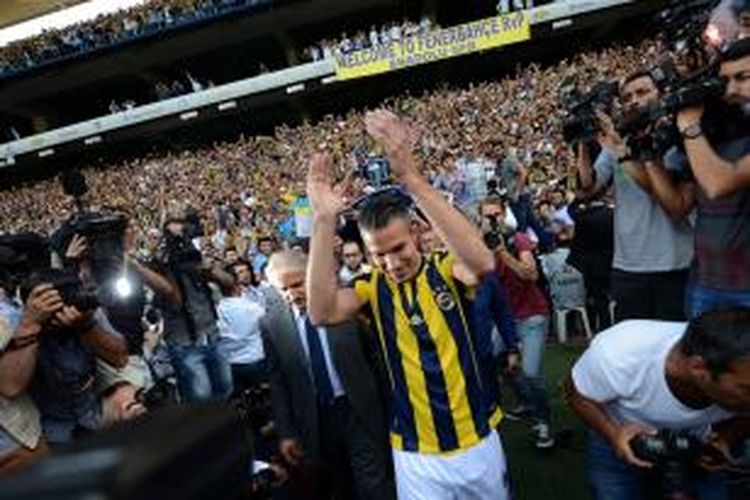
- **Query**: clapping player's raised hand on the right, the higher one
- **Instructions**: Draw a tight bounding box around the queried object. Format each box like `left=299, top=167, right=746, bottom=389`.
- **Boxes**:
left=365, top=109, right=419, bottom=181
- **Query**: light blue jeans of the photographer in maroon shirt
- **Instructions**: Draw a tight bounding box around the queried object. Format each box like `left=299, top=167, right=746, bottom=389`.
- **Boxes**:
left=508, top=314, right=550, bottom=422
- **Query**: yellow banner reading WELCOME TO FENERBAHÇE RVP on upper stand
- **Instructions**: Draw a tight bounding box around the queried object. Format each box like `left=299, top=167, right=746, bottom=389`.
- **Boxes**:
left=336, top=12, right=531, bottom=80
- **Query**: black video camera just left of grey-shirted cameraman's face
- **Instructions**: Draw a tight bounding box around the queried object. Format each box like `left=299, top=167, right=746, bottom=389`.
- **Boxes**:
left=561, top=80, right=619, bottom=144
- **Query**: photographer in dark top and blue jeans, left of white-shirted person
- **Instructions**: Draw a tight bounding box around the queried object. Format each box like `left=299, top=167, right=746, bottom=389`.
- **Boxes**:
left=155, top=218, right=234, bottom=401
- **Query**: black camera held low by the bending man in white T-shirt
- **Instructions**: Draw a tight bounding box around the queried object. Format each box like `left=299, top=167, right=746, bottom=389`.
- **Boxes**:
left=630, top=430, right=724, bottom=500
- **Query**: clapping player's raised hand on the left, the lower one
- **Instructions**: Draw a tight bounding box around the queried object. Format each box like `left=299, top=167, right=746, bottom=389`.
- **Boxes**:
left=307, top=153, right=351, bottom=216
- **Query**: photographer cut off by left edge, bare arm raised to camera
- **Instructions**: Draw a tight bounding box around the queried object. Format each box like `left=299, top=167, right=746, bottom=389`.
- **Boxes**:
left=0, top=273, right=63, bottom=477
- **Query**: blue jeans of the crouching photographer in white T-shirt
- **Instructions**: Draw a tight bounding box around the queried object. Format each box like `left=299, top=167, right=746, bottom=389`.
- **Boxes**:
left=587, top=431, right=728, bottom=500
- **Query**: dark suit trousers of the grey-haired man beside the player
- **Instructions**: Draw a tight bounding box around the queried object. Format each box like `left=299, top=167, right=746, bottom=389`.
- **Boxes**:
left=319, top=397, right=396, bottom=500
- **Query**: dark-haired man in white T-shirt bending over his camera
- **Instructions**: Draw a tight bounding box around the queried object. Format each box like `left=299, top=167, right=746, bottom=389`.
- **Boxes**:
left=567, top=309, right=750, bottom=500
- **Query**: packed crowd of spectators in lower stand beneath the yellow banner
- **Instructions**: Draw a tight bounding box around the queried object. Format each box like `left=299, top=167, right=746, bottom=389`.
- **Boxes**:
left=0, top=36, right=659, bottom=258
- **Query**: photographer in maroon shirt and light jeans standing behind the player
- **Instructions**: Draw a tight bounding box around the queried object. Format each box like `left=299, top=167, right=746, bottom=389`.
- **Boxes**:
left=480, top=196, right=555, bottom=449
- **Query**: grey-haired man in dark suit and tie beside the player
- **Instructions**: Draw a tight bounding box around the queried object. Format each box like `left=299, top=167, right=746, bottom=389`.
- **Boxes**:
left=261, top=251, right=395, bottom=500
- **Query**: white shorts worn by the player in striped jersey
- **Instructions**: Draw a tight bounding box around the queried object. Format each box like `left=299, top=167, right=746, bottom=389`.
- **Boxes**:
left=393, top=430, right=510, bottom=500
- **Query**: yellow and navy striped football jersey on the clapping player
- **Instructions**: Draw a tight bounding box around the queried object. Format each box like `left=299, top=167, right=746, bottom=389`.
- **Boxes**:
left=354, top=254, right=502, bottom=453
